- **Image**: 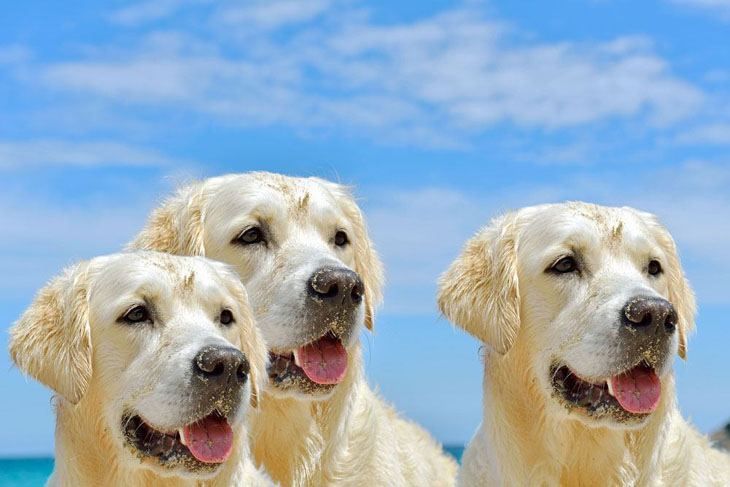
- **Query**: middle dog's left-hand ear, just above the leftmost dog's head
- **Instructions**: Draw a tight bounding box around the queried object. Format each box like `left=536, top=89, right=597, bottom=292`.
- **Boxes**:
left=127, top=183, right=205, bottom=255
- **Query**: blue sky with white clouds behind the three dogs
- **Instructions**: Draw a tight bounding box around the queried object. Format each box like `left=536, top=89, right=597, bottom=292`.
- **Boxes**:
left=0, top=0, right=730, bottom=455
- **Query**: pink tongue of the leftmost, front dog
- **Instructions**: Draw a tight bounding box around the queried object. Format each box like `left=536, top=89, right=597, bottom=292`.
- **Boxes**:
left=182, top=415, right=233, bottom=463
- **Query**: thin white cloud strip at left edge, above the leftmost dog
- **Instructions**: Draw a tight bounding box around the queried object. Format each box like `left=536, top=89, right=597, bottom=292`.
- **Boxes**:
left=0, top=139, right=173, bottom=170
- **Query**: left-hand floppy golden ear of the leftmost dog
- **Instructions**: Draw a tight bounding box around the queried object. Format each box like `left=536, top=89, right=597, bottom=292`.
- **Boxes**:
left=10, top=263, right=92, bottom=404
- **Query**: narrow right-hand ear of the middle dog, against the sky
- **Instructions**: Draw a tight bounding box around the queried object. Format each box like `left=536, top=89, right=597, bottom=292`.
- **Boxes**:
left=319, top=180, right=383, bottom=331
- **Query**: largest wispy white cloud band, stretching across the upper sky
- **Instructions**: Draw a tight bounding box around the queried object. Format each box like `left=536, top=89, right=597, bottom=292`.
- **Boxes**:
left=32, top=0, right=704, bottom=145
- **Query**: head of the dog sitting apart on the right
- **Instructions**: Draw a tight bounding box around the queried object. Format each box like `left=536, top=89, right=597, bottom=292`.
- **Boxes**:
left=438, top=203, right=695, bottom=427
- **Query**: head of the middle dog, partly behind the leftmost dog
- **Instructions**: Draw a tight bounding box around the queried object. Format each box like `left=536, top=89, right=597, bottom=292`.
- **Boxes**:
left=132, top=173, right=382, bottom=399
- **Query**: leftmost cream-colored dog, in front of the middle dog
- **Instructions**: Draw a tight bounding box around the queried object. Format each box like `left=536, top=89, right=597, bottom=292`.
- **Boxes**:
left=10, top=252, right=271, bottom=486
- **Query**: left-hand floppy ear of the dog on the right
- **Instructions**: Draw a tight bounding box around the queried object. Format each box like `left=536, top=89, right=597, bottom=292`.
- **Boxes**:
left=438, top=213, right=520, bottom=354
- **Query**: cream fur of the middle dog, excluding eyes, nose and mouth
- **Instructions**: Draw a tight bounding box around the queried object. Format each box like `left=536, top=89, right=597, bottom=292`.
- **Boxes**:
left=131, top=173, right=456, bottom=486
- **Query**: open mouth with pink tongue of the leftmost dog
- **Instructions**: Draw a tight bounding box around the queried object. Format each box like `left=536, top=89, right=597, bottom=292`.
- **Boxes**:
left=122, top=411, right=233, bottom=471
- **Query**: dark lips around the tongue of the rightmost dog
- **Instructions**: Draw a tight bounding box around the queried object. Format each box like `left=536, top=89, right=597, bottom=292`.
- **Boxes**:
left=550, top=359, right=655, bottom=418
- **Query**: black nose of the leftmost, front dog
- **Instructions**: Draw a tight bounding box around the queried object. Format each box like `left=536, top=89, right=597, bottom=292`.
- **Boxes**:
left=193, top=345, right=249, bottom=385
